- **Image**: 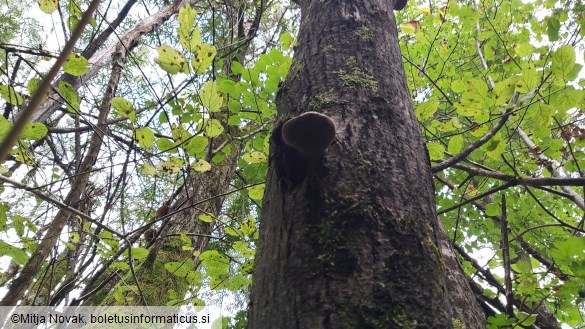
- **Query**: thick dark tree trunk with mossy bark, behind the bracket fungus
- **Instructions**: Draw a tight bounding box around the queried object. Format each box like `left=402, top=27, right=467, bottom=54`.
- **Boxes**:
left=249, top=0, right=452, bottom=329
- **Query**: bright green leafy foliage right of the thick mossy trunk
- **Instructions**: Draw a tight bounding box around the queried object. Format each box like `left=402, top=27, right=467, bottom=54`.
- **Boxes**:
left=397, top=1, right=585, bottom=322
